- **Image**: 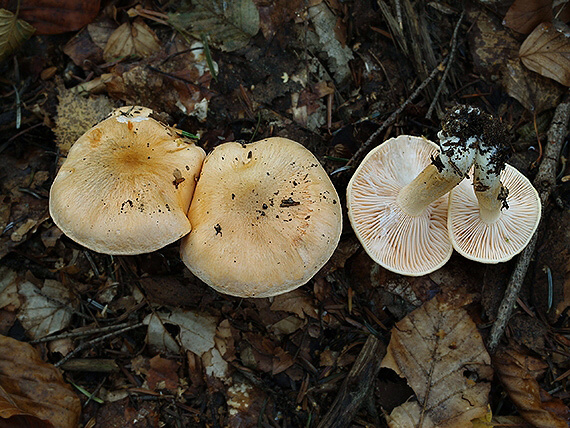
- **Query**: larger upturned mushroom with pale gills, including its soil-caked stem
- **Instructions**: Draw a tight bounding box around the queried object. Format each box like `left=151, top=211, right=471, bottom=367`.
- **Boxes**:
left=347, top=107, right=479, bottom=276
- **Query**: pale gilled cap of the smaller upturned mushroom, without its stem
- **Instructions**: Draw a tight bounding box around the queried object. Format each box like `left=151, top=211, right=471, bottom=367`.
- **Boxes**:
left=448, top=165, right=541, bottom=264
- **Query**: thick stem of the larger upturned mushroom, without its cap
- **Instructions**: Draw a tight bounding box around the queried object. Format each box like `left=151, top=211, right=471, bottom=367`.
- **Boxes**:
left=396, top=131, right=477, bottom=217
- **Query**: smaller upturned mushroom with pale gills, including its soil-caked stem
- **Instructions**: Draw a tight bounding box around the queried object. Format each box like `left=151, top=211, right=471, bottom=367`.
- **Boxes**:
left=448, top=115, right=541, bottom=264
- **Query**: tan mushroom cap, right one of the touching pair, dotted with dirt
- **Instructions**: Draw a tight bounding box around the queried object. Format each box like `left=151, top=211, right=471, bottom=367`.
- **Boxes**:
left=181, top=137, right=342, bottom=297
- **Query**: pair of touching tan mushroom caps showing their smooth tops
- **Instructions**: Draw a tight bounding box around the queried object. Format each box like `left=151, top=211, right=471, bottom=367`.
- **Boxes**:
left=49, top=107, right=342, bottom=297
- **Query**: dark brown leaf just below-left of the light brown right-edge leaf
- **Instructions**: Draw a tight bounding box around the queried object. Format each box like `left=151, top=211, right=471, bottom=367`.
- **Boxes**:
left=502, top=59, right=566, bottom=114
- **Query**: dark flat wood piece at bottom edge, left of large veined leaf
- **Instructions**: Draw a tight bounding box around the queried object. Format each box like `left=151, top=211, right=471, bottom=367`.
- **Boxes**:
left=312, top=335, right=386, bottom=428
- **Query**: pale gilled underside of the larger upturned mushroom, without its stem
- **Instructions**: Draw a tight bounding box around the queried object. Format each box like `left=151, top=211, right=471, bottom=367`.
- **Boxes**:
left=347, top=135, right=453, bottom=276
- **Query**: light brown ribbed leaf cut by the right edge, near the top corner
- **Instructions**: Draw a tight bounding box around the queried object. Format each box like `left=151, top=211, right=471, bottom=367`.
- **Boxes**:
left=519, top=22, right=570, bottom=86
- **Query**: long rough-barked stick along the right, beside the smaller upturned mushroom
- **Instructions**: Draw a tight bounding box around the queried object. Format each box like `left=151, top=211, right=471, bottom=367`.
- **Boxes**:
left=487, top=92, right=570, bottom=353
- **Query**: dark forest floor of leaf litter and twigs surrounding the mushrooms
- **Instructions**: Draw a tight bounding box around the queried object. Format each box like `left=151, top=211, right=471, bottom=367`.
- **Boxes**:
left=0, top=0, right=570, bottom=428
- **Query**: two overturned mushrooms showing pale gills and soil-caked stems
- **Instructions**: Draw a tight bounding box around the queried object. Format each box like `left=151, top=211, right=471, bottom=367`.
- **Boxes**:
left=347, top=106, right=540, bottom=276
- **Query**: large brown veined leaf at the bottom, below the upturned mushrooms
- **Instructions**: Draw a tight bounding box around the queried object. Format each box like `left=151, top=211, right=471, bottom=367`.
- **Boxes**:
left=382, top=296, right=492, bottom=428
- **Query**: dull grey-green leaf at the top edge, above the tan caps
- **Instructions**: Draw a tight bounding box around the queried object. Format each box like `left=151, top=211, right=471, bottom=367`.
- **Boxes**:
left=168, top=0, right=259, bottom=52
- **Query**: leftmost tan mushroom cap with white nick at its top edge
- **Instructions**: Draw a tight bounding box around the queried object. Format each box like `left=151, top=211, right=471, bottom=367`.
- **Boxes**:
left=49, top=107, right=205, bottom=254
